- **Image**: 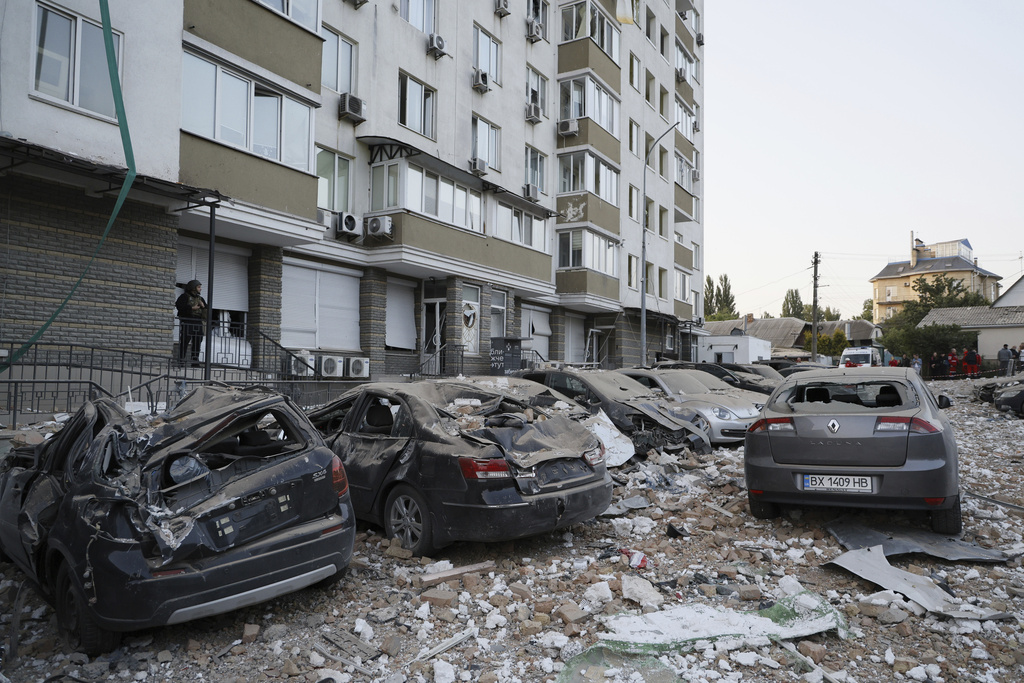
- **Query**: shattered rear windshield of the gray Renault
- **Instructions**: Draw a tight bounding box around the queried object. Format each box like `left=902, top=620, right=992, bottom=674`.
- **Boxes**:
left=770, top=380, right=921, bottom=413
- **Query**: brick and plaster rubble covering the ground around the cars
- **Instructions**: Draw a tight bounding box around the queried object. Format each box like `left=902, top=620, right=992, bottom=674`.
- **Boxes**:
left=0, top=380, right=1024, bottom=683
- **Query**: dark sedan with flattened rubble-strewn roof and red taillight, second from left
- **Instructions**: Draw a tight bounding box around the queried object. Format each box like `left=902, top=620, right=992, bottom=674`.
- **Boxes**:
left=309, top=381, right=612, bottom=555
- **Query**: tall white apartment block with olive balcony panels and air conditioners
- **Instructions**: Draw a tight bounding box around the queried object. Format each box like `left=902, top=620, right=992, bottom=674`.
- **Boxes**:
left=0, top=0, right=703, bottom=375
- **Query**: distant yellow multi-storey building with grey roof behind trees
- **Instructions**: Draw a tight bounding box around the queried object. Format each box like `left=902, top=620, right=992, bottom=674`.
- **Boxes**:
left=870, top=233, right=1002, bottom=323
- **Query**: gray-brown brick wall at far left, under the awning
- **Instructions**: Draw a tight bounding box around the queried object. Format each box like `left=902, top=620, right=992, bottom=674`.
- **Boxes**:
left=0, top=174, right=178, bottom=355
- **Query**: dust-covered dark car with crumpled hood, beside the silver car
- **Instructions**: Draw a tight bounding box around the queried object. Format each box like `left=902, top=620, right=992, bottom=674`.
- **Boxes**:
left=515, top=368, right=711, bottom=455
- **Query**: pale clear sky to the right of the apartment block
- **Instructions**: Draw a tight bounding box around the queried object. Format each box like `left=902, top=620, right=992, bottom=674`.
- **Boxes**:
left=701, top=0, right=1024, bottom=318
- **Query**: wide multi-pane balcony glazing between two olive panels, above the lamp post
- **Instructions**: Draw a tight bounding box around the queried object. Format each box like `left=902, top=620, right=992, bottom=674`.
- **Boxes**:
left=181, top=52, right=312, bottom=171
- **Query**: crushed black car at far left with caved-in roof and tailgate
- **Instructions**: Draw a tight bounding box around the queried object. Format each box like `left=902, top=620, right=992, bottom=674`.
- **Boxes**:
left=0, top=386, right=355, bottom=654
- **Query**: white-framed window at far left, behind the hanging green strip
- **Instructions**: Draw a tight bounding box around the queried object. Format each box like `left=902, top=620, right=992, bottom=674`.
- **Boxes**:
left=35, top=5, right=121, bottom=119
